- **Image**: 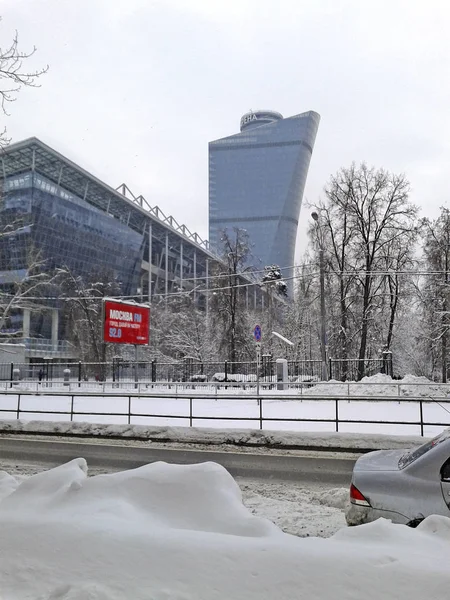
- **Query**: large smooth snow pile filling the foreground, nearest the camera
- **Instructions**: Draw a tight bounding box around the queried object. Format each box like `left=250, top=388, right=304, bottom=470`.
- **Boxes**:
left=0, top=459, right=450, bottom=600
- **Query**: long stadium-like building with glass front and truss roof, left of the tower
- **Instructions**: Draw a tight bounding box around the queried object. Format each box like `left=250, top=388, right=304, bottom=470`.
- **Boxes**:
left=0, top=138, right=263, bottom=359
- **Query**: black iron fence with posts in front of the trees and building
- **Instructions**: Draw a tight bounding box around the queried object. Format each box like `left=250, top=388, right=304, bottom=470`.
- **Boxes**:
left=0, top=355, right=393, bottom=383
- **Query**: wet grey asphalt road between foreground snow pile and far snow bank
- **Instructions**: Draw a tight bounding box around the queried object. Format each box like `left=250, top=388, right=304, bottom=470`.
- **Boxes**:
left=0, top=438, right=356, bottom=486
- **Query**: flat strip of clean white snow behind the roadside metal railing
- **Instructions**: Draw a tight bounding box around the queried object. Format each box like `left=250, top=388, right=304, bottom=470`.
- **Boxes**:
left=0, top=374, right=450, bottom=436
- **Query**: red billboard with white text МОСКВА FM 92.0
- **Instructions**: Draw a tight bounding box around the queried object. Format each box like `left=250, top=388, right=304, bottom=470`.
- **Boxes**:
left=103, top=300, right=150, bottom=345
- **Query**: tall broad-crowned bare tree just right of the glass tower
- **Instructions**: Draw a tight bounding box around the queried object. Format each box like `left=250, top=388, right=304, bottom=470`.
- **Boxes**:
left=310, top=163, right=418, bottom=378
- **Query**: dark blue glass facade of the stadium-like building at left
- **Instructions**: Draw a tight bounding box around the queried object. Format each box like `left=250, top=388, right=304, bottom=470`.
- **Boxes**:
left=0, top=171, right=144, bottom=339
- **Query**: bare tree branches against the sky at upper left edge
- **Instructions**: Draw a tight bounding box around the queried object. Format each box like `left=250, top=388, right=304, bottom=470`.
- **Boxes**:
left=0, top=21, right=48, bottom=147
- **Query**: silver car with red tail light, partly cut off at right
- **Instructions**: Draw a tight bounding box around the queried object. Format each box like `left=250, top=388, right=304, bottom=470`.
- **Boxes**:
left=345, top=429, right=450, bottom=527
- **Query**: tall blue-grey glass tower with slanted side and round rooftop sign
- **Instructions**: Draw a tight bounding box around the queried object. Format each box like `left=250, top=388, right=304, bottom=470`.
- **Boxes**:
left=209, top=111, right=320, bottom=286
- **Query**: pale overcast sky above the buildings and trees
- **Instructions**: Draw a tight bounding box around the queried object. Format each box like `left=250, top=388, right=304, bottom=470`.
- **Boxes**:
left=0, top=0, right=450, bottom=259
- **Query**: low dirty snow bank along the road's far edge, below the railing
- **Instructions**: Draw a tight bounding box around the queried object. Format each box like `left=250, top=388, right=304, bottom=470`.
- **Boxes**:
left=0, top=421, right=427, bottom=452
